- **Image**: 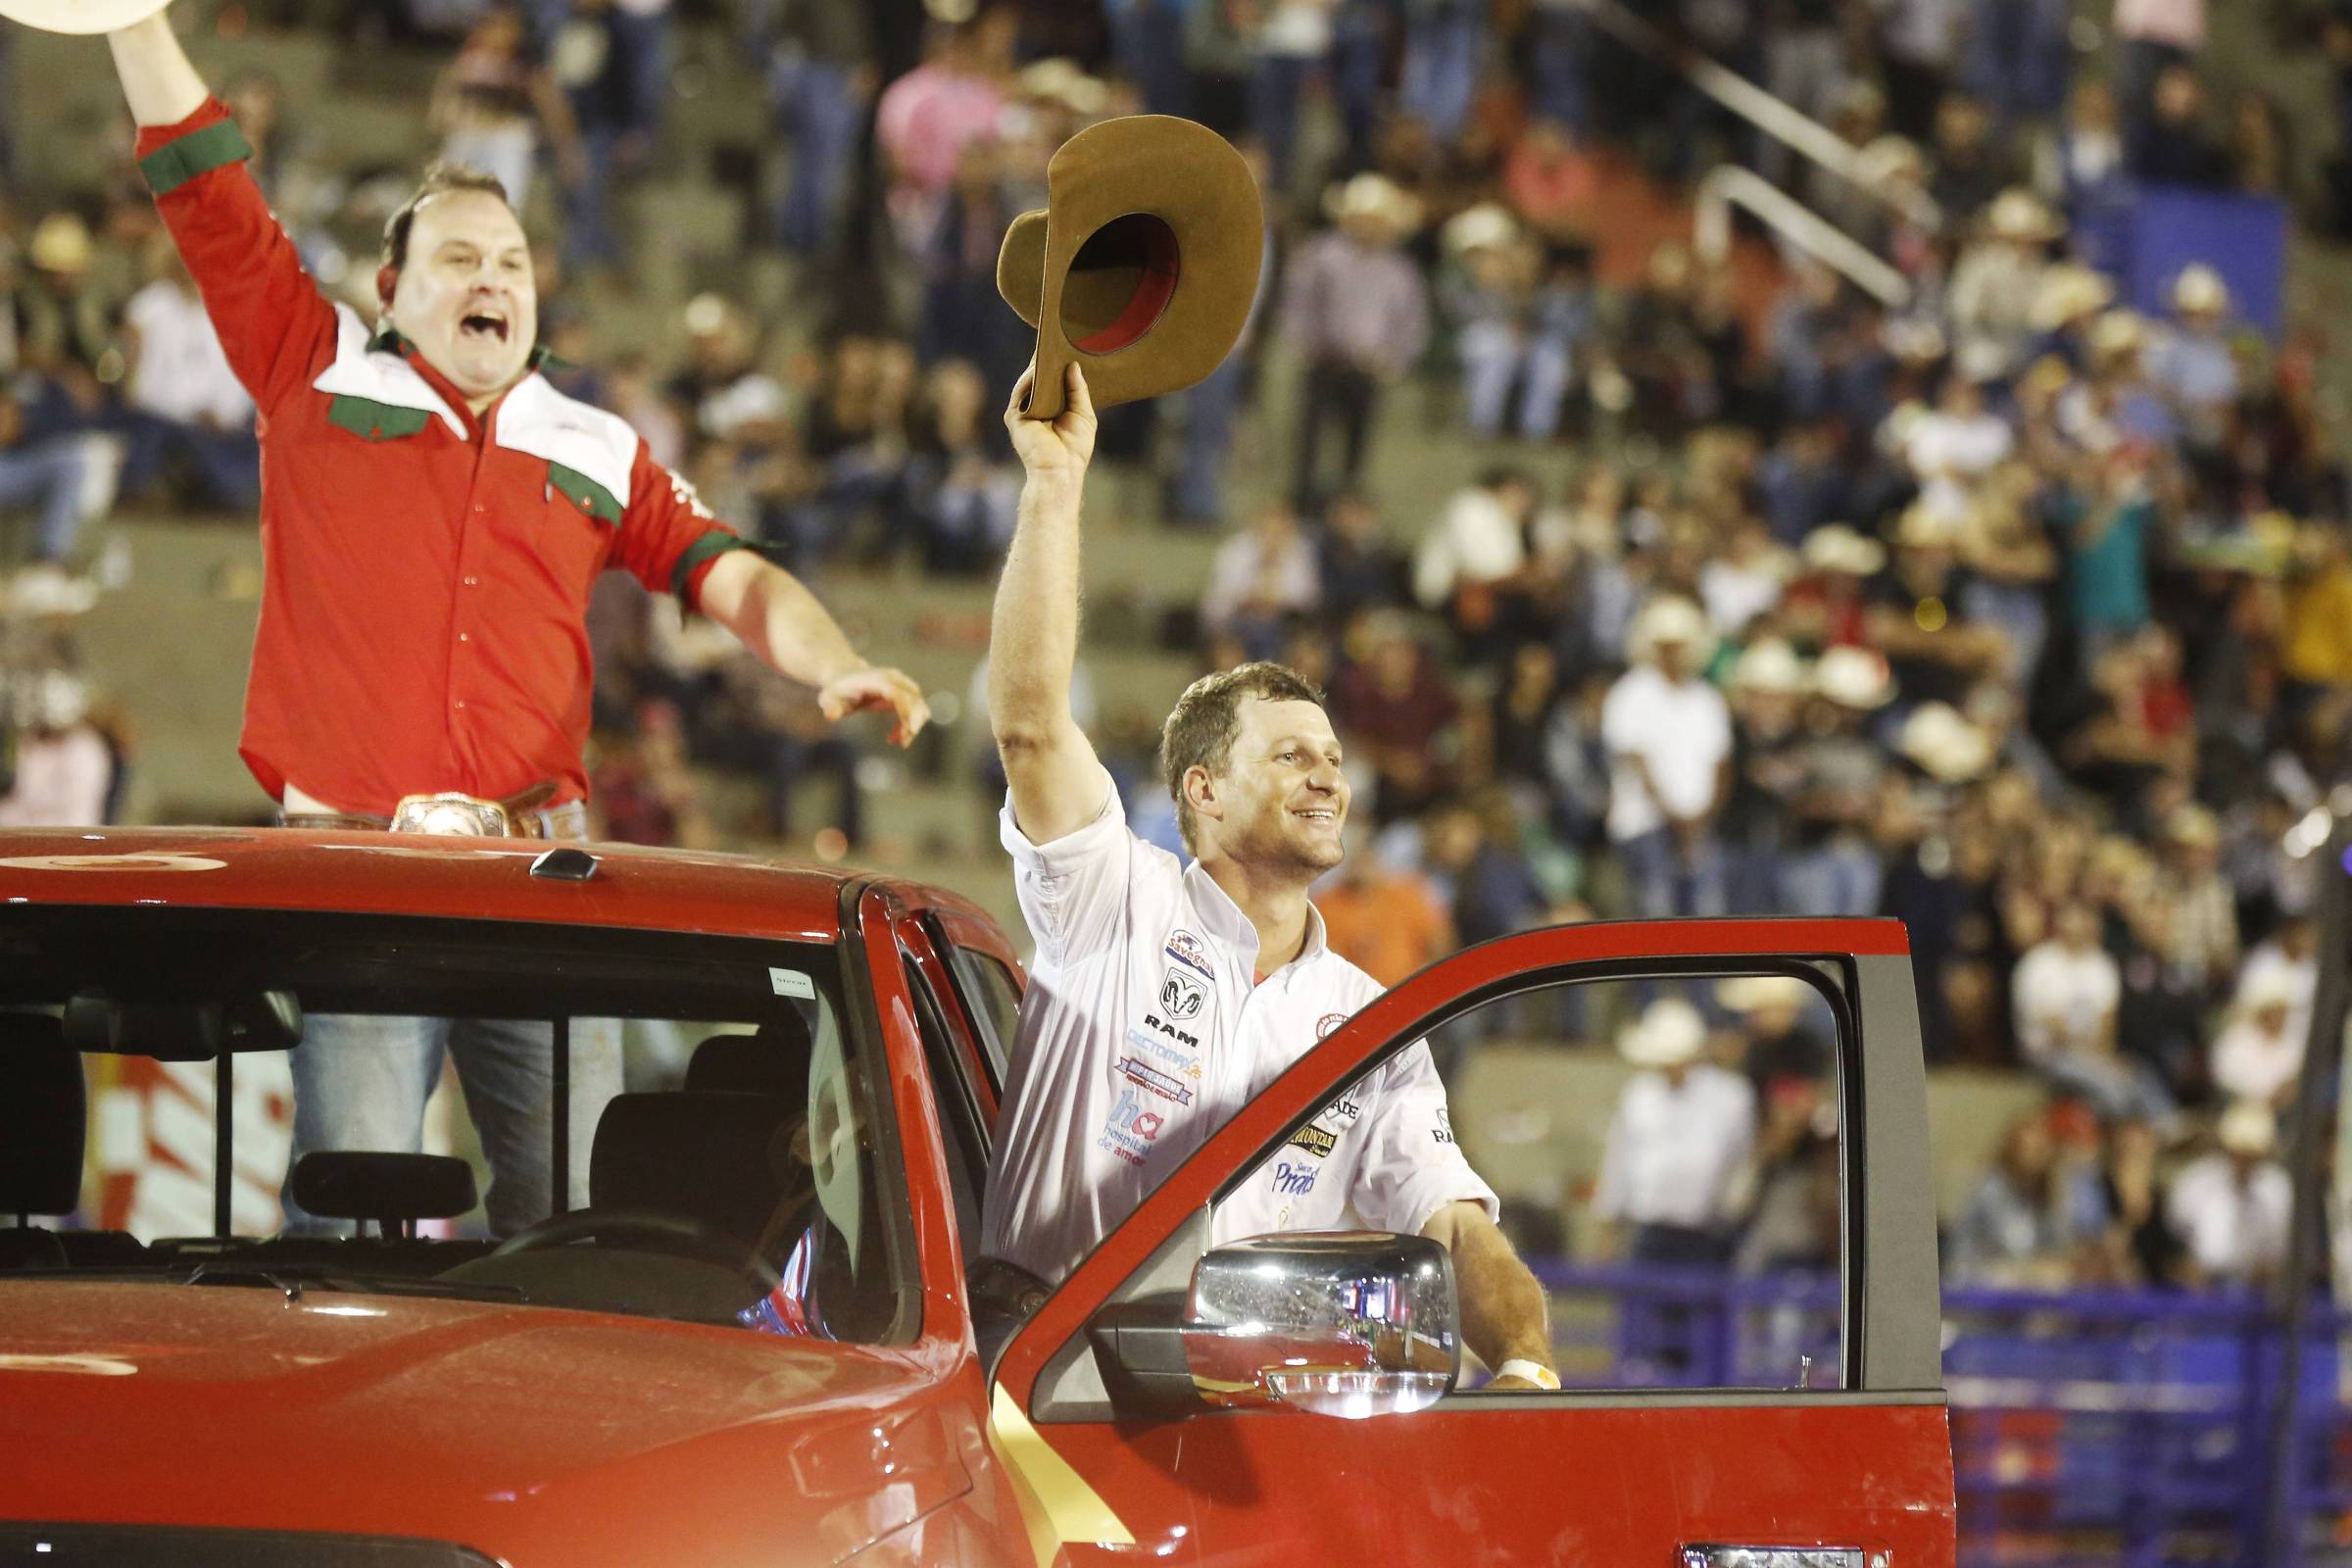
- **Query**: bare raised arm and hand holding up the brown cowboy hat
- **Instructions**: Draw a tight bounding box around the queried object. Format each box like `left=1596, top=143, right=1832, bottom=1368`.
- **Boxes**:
left=988, top=365, right=1105, bottom=844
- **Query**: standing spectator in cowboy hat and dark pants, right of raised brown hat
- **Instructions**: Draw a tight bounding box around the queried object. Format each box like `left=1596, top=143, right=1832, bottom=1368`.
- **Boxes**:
left=1282, top=174, right=1430, bottom=513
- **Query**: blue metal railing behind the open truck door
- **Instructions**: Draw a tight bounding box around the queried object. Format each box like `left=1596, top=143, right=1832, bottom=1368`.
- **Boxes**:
left=1534, top=1260, right=2352, bottom=1568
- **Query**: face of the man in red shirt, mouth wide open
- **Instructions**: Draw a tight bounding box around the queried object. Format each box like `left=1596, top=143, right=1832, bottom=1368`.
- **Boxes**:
left=383, top=190, right=539, bottom=409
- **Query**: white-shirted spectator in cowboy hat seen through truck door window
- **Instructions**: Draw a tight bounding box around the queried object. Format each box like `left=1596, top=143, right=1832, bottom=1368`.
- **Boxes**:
left=1592, top=997, right=1757, bottom=1265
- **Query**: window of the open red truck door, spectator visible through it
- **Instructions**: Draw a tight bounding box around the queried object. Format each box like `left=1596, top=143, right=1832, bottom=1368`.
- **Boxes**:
left=1216, top=966, right=1848, bottom=1390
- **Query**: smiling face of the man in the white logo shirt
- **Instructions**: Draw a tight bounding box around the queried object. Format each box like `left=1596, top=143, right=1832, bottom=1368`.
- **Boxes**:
left=1195, top=696, right=1348, bottom=877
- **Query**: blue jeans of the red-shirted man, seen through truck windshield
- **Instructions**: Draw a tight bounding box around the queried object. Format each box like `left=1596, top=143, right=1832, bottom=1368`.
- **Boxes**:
left=280, top=1013, right=621, bottom=1237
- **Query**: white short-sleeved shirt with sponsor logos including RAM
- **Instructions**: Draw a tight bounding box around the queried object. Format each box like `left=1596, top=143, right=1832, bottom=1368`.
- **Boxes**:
left=981, top=773, right=1500, bottom=1281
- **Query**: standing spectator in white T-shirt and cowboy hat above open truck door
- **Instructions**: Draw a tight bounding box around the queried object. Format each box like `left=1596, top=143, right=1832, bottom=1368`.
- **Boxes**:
left=1601, top=595, right=1731, bottom=917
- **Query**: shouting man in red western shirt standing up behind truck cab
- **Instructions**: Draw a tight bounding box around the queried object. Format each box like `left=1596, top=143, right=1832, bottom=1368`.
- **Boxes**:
left=108, top=14, right=929, bottom=1234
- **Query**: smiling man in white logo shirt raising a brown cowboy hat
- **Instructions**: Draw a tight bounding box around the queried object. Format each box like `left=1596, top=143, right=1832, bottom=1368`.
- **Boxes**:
left=981, top=365, right=1559, bottom=1390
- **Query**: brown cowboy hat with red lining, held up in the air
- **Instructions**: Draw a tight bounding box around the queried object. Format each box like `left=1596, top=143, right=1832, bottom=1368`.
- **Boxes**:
left=998, top=116, right=1265, bottom=418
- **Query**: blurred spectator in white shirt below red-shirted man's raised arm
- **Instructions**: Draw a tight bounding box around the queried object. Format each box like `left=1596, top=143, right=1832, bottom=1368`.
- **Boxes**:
left=122, top=237, right=261, bottom=513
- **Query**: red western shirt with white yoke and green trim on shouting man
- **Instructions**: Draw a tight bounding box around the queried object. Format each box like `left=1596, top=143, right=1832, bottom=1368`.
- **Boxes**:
left=139, top=99, right=743, bottom=815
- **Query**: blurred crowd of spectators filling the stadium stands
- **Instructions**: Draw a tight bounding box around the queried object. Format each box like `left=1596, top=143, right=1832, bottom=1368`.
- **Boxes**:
left=0, top=0, right=2352, bottom=1279
